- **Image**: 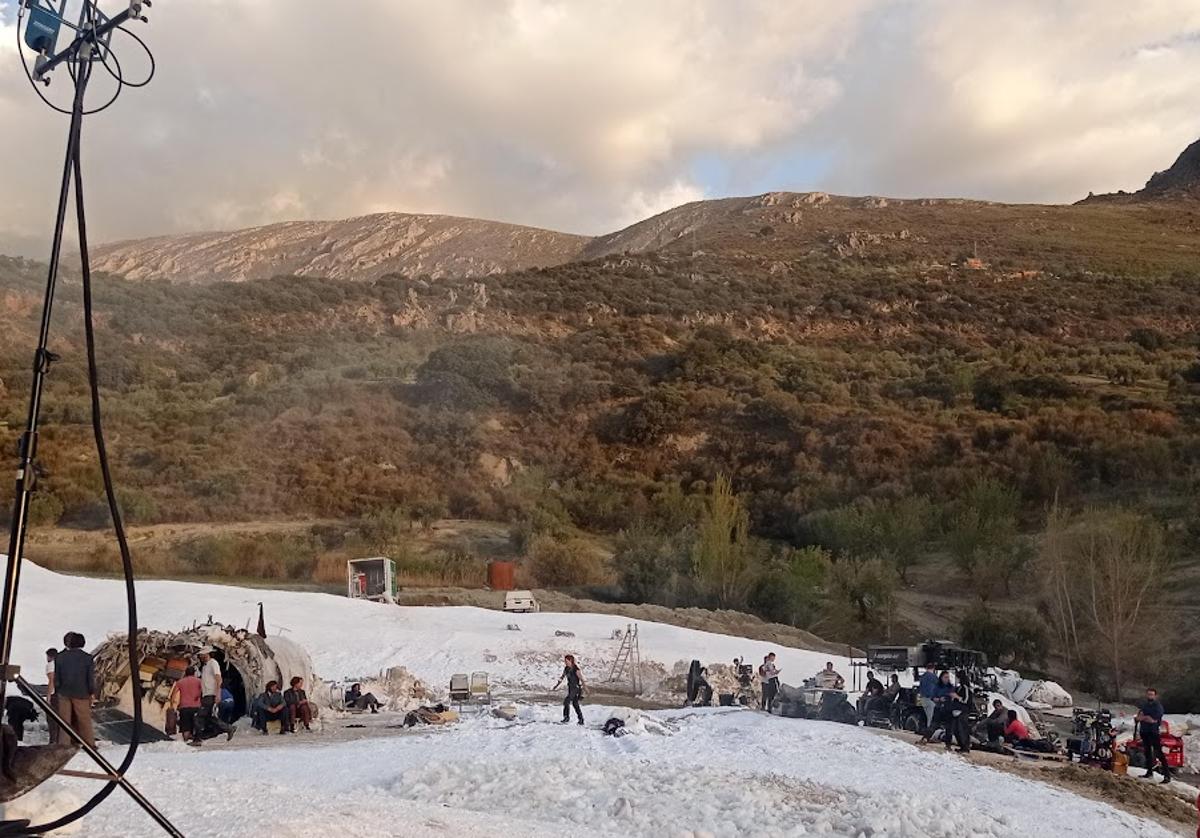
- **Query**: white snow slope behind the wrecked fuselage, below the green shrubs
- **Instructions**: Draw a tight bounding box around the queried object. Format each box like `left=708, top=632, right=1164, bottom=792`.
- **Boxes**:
left=13, top=563, right=850, bottom=690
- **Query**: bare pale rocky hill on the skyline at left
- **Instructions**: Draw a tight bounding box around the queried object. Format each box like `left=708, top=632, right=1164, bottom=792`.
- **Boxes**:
left=94, top=213, right=588, bottom=282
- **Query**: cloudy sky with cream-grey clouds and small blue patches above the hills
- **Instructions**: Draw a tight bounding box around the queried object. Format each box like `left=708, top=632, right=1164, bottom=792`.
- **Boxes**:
left=0, top=0, right=1200, bottom=249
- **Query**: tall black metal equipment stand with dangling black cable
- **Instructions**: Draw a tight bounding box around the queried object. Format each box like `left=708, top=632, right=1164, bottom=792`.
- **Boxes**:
left=0, top=1, right=182, bottom=838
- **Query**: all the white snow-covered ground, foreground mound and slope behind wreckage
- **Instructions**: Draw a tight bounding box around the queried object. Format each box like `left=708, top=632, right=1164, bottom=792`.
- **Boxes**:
left=5, top=565, right=1190, bottom=838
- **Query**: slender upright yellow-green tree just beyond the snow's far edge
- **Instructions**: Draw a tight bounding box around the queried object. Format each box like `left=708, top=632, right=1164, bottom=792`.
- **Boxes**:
left=691, top=474, right=754, bottom=607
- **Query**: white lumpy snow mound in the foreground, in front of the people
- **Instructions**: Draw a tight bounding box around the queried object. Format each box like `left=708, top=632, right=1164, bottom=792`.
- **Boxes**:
left=8, top=706, right=1174, bottom=838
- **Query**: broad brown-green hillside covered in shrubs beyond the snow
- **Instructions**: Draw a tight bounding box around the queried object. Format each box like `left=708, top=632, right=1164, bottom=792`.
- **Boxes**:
left=0, top=187, right=1200, bottom=696
